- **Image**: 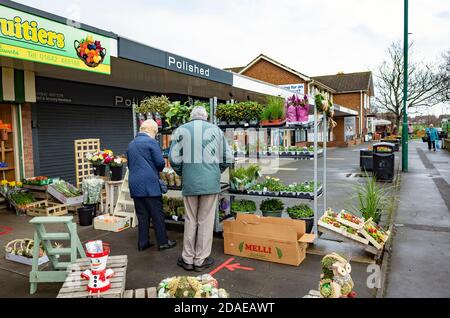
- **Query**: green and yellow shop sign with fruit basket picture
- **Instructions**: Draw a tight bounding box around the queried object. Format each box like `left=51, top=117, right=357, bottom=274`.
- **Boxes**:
left=0, top=5, right=113, bottom=74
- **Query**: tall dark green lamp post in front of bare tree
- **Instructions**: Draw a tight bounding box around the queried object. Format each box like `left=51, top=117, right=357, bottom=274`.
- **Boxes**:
left=402, top=0, right=409, bottom=172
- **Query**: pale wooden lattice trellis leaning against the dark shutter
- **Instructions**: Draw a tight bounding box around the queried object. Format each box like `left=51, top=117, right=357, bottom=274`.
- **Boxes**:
left=74, top=139, right=100, bottom=188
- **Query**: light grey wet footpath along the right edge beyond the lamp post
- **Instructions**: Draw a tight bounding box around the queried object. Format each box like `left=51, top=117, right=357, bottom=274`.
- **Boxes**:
left=385, top=142, right=450, bottom=297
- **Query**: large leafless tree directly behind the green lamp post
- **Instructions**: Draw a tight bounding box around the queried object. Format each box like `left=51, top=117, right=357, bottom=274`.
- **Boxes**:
left=375, top=42, right=442, bottom=127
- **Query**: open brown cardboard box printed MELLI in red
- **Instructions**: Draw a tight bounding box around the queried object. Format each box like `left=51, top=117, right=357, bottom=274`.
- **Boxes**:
left=223, top=214, right=315, bottom=266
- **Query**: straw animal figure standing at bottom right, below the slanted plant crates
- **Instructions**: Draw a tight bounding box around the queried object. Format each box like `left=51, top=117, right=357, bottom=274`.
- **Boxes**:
left=319, top=253, right=356, bottom=298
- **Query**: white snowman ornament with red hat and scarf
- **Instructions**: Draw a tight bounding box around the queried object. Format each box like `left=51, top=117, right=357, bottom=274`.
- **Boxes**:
left=81, top=241, right=114, bottom=294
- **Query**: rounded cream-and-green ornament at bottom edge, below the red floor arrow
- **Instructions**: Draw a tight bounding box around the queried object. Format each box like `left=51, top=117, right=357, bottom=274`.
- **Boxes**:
left=158, top=274, right=230, bottom=298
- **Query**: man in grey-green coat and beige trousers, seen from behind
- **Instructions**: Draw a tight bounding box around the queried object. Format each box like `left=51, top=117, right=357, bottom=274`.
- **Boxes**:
left=169, top=107, right=233, bottom=272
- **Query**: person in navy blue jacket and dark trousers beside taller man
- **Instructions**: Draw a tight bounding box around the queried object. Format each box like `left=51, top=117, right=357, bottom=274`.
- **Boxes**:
left=127, top=120, right=176, bottom=251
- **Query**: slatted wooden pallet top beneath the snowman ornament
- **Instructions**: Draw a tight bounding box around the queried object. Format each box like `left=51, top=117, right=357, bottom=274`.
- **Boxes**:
left=57, top=255, right=128, bottom=298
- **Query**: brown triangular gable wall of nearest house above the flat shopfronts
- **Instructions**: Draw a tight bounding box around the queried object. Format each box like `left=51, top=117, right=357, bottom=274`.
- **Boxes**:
left=243, top=60, right=308, bottom=94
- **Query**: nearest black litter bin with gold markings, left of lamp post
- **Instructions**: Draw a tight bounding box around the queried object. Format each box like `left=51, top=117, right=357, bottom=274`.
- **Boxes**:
left=373, top=142, right=395, bottom=182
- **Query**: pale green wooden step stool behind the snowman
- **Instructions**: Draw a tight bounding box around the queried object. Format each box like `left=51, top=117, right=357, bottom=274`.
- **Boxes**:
left=30, top=216, right=86, bottom=294
